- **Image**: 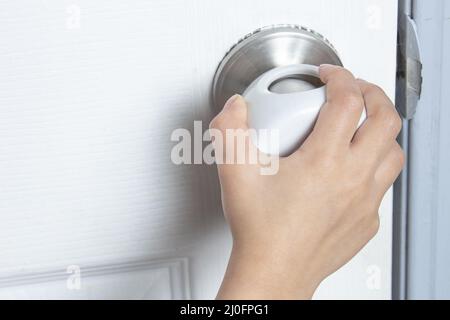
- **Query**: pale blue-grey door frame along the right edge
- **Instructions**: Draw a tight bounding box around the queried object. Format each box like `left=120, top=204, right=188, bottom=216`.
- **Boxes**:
left=392, top=0, right=450, bottom=299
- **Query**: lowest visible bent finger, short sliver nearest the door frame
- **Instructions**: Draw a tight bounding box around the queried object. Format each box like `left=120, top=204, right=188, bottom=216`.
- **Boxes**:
left=375, top=142, right=405, bottom=198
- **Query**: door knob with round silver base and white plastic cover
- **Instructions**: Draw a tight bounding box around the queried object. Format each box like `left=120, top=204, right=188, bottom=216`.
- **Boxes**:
left=212, top=25, right=366, bottom=156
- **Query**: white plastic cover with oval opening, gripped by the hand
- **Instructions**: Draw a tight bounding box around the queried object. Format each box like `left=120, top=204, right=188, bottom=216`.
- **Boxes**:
left=243, top=64, right=366, bottom=157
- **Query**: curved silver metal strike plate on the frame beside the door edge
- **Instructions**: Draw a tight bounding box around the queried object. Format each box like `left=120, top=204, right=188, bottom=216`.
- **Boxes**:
left=396, top=4, right=423, bottom=120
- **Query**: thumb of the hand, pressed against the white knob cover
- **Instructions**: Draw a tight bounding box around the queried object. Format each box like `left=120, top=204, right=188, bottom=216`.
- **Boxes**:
left=210, top=95, right=257, bottom=173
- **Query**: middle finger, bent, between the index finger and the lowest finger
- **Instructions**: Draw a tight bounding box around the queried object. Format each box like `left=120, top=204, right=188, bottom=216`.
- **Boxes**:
left=352, top=80, right=402, bottom=166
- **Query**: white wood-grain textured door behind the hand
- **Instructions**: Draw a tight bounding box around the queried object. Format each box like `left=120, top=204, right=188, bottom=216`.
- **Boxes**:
left=0, top=0, right=397, bottom=299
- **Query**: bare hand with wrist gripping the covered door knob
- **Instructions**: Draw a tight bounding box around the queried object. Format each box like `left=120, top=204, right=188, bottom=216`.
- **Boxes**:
left=210, top=65, right=404, bottom=300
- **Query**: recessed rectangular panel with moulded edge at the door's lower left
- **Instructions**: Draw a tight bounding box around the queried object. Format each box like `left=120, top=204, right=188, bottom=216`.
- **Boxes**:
left=0, top=258, right=191, bottom=300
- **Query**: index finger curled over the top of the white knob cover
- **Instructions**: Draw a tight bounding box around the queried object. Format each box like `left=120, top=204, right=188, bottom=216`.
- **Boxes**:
left=311, top=65, right=364, bottom=147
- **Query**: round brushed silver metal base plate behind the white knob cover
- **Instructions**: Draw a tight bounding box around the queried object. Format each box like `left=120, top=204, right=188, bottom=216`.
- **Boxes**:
left=212, top=25, right=343, bottom=113
